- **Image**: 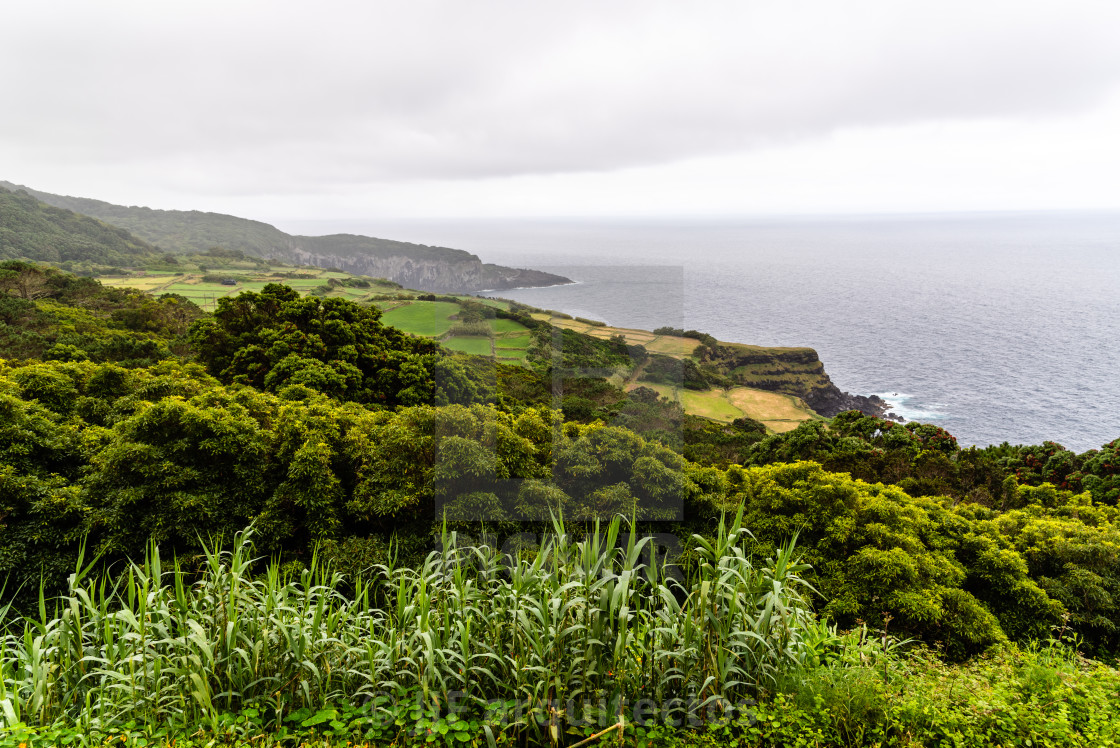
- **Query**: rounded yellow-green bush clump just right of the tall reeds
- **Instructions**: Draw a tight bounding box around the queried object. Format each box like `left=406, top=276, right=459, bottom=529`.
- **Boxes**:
left=738, top=462, right=1062, bottom=657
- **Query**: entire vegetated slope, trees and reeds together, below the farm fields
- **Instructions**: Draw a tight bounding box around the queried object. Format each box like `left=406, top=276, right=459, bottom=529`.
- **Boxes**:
left=0, top=228, right=1120, bottom=745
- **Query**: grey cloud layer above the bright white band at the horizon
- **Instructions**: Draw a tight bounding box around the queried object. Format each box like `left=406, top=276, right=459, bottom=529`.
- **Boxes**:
left=0, top=0, right=1120, bottom=194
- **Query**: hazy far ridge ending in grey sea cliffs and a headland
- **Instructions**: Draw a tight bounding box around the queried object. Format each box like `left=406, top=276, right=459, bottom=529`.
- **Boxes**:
left=0, top=181, right=570, bottom=293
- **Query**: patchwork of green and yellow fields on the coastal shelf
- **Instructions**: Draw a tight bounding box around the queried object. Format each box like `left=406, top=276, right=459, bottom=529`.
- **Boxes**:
left=91, top=264, right=885, bottom=433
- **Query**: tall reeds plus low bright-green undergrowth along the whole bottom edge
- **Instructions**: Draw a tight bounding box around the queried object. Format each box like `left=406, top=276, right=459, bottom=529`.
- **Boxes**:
left=8, top=520, right=1120, bottom=748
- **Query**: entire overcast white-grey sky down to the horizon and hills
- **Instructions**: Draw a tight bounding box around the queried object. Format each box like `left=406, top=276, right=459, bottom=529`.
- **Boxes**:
left=0, top=0, right=1120, bottom=222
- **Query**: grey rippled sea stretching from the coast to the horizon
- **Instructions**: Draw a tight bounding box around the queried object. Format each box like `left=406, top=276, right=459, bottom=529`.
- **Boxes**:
left=281, top=213, right=1120, bottom=451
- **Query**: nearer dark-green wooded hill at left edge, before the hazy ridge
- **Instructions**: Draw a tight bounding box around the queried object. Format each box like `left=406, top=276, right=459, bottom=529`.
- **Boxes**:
left=0, top=183, right=161, bottom=265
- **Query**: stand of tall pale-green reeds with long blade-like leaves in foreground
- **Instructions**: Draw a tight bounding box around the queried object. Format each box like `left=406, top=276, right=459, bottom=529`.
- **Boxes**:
left=0, top=513, right=819, bottom=733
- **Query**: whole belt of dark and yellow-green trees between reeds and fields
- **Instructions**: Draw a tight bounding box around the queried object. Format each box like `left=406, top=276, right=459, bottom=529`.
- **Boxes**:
left=0, top=262, right=1120, bottom=657
